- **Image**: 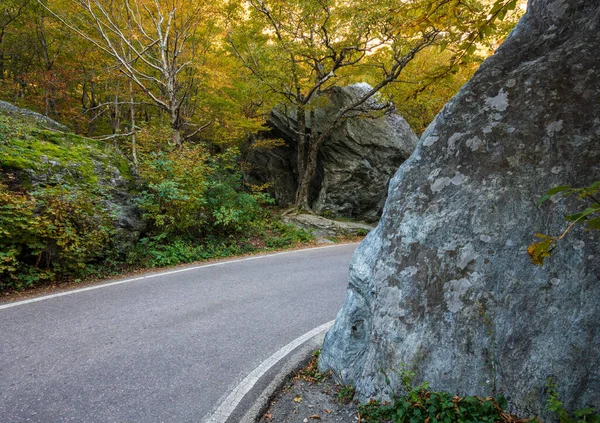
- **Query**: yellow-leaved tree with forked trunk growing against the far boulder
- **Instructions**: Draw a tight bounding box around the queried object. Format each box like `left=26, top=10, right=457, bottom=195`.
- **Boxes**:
left=228, top=0, right=516, bottom=210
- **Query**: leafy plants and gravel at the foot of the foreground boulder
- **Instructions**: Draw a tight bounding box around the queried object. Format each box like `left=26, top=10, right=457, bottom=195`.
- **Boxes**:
left=274, top=350, right=600, bottom=423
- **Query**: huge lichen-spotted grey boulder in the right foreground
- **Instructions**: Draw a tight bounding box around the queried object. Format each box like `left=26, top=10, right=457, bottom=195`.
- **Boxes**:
left=320, top=0, right=600, bottom=421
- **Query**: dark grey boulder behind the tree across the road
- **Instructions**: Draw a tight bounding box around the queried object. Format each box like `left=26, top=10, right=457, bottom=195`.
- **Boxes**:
left=244, top=84, right=418, bottom=222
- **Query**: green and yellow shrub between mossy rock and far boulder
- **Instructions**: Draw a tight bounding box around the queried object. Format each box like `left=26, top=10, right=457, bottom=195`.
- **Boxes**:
left=139, top=145, right=271, bottom=238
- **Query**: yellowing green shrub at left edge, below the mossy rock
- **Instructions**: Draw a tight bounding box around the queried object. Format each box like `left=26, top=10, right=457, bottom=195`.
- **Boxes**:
left=0, top=183, right=115, bottom=289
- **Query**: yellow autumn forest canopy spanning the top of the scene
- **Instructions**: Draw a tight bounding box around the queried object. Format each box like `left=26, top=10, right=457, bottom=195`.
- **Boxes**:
left=0, top=0, right=523, bottom=143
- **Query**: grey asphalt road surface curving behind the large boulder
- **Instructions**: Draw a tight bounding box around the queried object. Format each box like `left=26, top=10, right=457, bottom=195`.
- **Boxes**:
left=0, top=244, right=356, bottom=423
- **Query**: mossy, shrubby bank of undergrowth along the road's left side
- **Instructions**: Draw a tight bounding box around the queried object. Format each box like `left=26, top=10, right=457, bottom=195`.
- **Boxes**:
left=0, top=115, right=311, bottom=292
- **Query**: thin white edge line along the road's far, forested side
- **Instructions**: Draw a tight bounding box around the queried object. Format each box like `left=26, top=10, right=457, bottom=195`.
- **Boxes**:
left=0, top=244, right=356, bottom=310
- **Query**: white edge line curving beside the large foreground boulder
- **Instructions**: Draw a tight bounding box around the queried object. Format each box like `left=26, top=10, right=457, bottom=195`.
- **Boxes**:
left=203, top=320, right=335, bottom=423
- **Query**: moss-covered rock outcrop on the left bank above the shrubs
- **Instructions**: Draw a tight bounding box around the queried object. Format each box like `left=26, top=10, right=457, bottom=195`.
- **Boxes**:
left=0, top=105, right=147, bottom=238
